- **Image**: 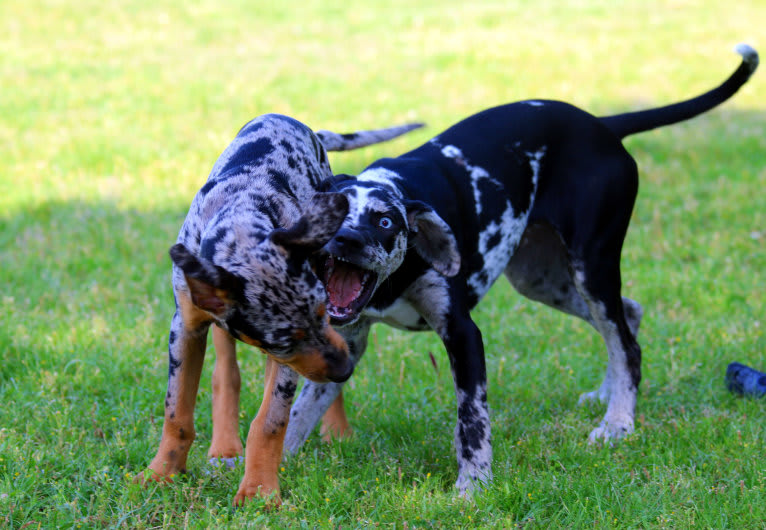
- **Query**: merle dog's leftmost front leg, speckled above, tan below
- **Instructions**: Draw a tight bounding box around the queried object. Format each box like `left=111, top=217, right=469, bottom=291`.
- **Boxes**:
left=144, top=299, right=209, bottom=482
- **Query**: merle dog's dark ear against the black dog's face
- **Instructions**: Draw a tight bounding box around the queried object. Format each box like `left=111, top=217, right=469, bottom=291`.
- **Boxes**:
left=269, top=193, right=348, bottom=252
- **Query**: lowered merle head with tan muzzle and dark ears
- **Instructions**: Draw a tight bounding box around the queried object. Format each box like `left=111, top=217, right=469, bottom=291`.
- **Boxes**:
left=170, top=193, right=353, bottom=382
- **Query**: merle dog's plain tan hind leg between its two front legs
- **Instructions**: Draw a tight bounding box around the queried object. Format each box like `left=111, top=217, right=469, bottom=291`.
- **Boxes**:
left=207, top=326, right=242, bottom=458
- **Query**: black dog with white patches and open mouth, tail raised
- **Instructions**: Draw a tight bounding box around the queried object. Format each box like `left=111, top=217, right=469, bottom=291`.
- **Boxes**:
left=285, top=45, right=758, bottom=494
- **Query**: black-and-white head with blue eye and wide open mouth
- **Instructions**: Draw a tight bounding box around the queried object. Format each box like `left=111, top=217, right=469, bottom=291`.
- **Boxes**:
left=317, top=169, right=460, bottom=325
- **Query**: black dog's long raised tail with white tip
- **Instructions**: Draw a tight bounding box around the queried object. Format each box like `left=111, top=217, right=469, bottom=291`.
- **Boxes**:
left=600, top=44, right=758, bottom=138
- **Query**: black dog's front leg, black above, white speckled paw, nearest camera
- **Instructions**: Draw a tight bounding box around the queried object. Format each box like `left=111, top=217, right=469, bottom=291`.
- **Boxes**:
left=442, top=311, right=492, bottom=496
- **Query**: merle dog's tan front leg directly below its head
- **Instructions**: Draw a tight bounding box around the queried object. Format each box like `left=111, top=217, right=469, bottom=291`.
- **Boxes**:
left=234, top=357, right=290, bottom=506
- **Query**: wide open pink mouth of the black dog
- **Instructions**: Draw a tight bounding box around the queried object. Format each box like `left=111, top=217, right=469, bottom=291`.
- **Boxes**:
left=324, top=255, right=378, bottom=324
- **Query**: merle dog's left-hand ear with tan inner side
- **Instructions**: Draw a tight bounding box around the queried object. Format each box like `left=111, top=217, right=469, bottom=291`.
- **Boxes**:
left=170, top=243, right=242, bottom=318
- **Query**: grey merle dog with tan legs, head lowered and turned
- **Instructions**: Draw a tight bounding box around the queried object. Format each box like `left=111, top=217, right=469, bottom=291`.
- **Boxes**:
left=139, top=114, right=420, bottom=503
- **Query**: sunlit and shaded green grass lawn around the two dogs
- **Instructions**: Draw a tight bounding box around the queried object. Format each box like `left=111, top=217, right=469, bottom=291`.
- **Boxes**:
left=0, top=0, right=766, bottom=528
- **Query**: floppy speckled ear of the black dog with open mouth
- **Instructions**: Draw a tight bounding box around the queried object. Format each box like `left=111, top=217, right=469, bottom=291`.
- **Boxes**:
left=403, top=201, right=460, bottom=276
